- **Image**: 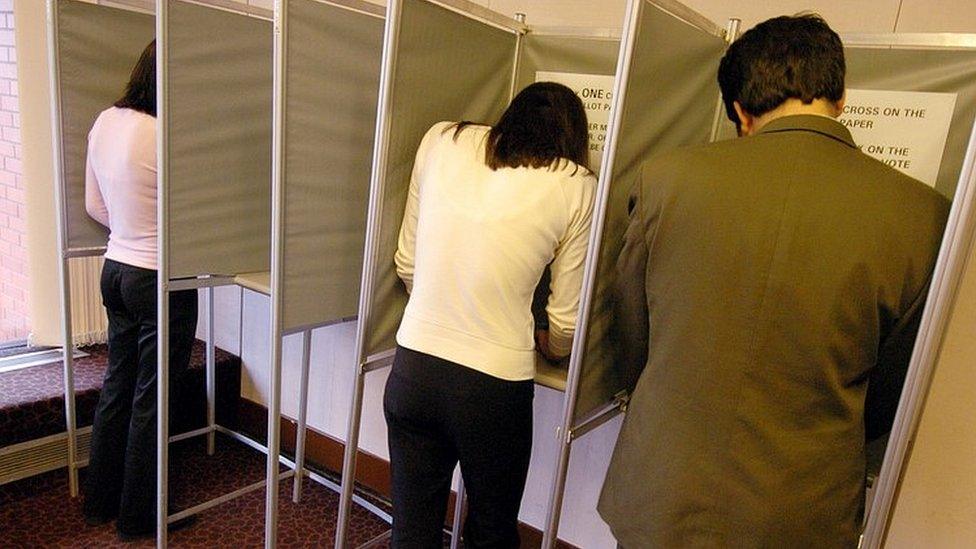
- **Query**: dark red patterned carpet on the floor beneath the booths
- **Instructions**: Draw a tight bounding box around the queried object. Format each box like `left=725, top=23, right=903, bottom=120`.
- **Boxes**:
left=0, top=437, right=389, bottom=548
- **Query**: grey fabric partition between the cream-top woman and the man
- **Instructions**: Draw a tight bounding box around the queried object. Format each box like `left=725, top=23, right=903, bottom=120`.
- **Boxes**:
left=574, top=2, right=726, bottom=422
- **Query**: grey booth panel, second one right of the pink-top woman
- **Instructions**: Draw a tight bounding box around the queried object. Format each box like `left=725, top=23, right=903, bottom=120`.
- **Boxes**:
left=282, top=0, right=383, bottom=330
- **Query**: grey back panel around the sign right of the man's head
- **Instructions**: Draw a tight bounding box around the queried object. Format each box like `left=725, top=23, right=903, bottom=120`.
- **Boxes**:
left=845, top=48, right=976, bottom=198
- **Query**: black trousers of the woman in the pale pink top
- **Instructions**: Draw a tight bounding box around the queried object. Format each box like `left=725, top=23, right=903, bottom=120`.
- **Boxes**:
left=85, top=259, right=197, bottom=534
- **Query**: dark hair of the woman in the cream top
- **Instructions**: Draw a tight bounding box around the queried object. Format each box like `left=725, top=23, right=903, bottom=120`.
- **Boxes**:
left=454, top=82, right=590, bottom=170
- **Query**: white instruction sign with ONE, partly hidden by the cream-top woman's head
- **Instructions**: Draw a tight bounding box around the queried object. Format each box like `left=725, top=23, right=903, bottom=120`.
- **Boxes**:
left=535, top=71, right=614, bottom=173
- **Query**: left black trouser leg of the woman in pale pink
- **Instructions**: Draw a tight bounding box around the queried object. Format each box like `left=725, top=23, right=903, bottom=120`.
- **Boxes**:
left=85, top=261, right=139, bottom=521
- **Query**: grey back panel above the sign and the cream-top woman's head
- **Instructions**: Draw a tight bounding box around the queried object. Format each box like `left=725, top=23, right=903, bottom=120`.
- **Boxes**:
left=516, top=32, right=620, bottom=89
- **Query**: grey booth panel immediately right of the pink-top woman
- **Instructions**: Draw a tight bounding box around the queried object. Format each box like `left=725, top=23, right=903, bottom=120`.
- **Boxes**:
left=165, top=0, right=272, bottom=278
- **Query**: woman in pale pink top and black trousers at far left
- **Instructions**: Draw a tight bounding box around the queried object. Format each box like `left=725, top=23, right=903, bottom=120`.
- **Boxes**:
left=85, top=40, right=197, bottom=539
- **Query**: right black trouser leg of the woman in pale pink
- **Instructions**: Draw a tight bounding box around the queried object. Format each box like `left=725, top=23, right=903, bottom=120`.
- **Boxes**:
left=118, top=273, right=197, bottom=534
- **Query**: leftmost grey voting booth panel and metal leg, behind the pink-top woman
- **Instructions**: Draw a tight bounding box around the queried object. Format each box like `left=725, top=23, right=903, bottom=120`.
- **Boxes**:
left=47, top=0, right=157, bottom=497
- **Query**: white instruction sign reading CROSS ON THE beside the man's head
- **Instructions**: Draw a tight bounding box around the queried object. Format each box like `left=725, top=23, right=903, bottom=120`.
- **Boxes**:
left=840, top=89, right=956, bottom=187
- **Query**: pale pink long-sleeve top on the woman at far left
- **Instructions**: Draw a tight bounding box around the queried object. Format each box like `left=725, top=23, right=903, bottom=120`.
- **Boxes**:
left=85, top=107, right=157, bottom=270
